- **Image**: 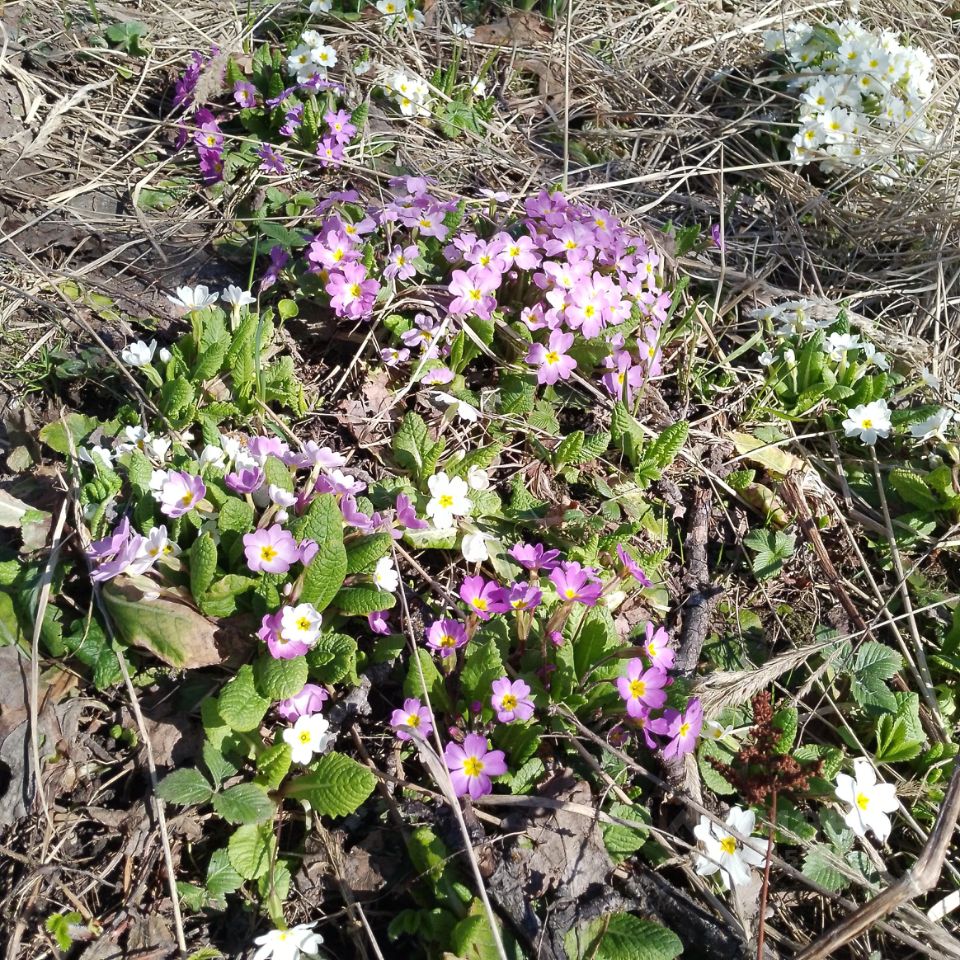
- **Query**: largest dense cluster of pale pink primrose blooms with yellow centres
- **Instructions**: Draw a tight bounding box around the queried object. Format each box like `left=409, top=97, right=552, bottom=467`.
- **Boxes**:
left=316, top=184, right=671, bottom=394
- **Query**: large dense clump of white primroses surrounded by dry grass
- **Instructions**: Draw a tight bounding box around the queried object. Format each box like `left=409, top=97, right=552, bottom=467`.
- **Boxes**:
left=764, top=20, right=934, bottom=179
